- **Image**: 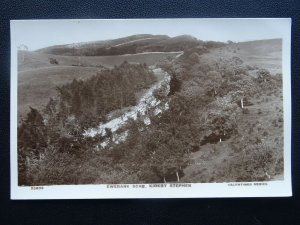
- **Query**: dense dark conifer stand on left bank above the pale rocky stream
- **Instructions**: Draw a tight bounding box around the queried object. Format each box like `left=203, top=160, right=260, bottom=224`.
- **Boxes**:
left=54, top=62, right=155, bottom=129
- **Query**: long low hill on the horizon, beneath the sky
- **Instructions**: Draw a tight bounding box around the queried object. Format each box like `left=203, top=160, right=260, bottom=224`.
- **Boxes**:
left=37, top=34, right=203, bottom=56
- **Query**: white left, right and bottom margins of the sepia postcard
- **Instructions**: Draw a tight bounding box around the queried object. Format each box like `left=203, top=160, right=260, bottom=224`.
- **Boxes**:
left=10, top=18, right=292, bottom=199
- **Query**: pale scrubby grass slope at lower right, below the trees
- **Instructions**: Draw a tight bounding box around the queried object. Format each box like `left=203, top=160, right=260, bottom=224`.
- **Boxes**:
left=182, top=89, right=283, bottom=183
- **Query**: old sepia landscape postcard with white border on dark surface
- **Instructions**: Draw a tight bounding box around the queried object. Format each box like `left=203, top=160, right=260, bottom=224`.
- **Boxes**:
left=11, top=18, right=292, bottom=199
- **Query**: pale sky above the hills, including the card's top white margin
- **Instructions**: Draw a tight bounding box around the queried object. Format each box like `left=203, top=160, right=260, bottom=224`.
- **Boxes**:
left=11, top=19, right=290, bottom=50
